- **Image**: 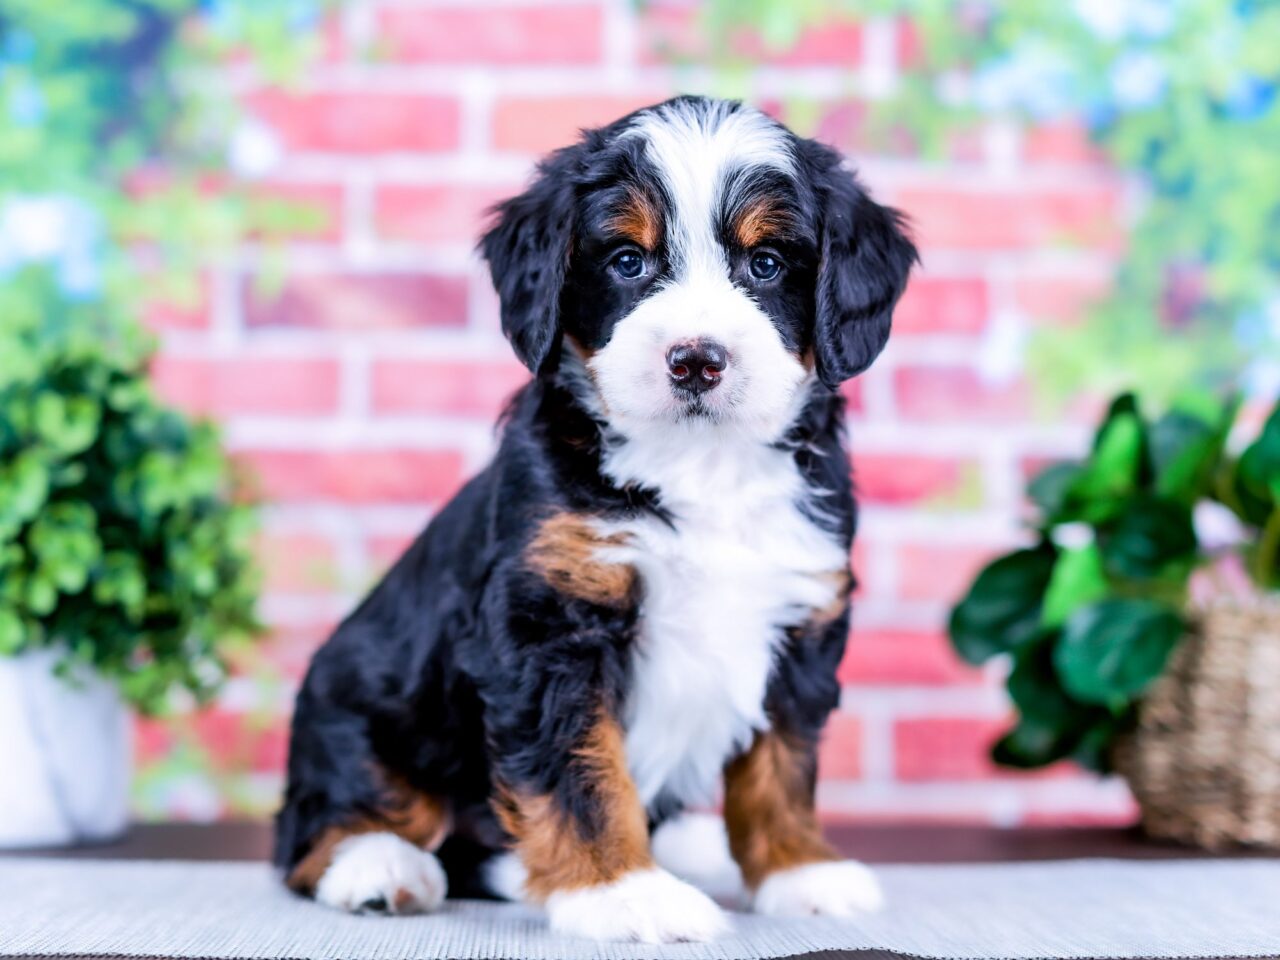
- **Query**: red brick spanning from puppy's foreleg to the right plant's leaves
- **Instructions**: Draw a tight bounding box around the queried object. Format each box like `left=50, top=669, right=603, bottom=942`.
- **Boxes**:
left=840, top=625, right=982, bottom=686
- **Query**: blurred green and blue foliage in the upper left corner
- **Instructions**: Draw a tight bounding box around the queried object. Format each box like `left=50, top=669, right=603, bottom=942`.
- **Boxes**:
left=0, top=0, right=325, bottom=316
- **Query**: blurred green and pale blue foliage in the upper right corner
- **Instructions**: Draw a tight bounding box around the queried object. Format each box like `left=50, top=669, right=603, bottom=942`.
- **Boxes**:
left=704, top=0, right=1280, bottom=399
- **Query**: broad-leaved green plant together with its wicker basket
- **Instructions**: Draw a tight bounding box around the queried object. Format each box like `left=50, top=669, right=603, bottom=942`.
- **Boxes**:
left=950, top=394, right=1280, bottom=846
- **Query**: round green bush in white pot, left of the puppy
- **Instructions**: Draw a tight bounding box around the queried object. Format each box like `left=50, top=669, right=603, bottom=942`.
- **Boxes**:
left=0, top=273, right=256, bottom=846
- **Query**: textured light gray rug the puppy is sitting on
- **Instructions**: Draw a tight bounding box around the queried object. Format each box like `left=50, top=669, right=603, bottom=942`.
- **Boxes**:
left=0, top=859, right=1280, bottom=960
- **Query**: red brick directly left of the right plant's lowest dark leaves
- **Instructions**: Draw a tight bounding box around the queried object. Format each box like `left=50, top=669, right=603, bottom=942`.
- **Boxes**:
left=893, top=717, right=1009, bottom=782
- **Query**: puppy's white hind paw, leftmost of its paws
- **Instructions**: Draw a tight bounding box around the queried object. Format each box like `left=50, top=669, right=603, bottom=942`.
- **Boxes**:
left=316, top=833, right=448, bottom=914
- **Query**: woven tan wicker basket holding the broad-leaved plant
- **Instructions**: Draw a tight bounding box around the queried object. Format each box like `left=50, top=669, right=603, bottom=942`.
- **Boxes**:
left=1114, top=600, right=1280, bottom=847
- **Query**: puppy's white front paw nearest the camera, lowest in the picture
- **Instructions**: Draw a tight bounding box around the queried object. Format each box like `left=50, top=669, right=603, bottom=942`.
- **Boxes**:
left=547, top=868, right=728, bottom=943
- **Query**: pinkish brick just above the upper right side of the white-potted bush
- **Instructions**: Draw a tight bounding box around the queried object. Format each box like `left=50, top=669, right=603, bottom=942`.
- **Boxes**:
left=151, top=353, right=338, bottom=416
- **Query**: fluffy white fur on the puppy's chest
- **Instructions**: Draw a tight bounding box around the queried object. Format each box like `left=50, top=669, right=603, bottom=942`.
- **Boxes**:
left=605, top=426, right=847, bottom=805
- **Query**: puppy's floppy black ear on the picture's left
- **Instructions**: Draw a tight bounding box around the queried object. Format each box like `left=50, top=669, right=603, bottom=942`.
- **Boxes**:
left=480, top=147, right=577, bottom=374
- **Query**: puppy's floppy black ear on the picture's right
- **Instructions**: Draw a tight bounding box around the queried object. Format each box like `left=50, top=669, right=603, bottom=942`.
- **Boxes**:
left=806, top=141, right=919, bottom=389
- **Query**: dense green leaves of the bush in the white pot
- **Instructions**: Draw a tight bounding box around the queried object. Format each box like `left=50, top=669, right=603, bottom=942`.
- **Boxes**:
left=0, top=273, right=256, bottom=710
